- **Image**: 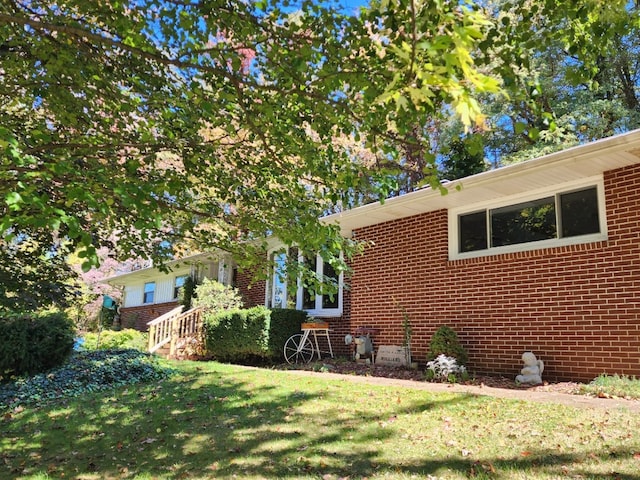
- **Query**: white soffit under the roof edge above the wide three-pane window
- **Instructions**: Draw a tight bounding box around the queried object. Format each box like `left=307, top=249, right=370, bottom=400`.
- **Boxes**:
left=323, top=130, right=640, bottom=236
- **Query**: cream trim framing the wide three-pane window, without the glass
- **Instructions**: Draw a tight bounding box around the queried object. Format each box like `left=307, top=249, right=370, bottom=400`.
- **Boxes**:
left=448, top=175, right=608, bottom=260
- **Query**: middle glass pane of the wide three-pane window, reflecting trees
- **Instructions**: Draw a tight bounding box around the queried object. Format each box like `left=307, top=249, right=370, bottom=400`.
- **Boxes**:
left=491, top=197, right=556, bottom=247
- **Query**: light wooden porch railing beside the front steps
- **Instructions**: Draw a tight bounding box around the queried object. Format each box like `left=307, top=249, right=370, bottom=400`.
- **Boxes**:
left=147, top=307, right=202, bottom=356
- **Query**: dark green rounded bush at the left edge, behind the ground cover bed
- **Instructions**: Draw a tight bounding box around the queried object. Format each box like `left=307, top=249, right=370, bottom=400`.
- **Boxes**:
left=0, top=312, right=75, bottom=380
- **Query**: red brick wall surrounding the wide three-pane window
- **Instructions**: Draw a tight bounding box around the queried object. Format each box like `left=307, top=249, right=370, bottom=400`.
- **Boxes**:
left=348, top=165, right=640, bottom=380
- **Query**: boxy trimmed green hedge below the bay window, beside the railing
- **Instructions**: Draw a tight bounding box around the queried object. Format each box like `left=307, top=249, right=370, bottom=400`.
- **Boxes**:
left=204, top=307, right=307, bottom=362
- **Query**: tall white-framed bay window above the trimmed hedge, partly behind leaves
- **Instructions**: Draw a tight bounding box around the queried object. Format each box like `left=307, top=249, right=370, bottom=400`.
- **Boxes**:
left=266, top=248, right=343, bottom=317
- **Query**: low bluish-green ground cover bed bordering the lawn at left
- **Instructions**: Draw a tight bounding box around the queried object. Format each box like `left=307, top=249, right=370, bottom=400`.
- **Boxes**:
left=0, top=350, right=173, bottom=411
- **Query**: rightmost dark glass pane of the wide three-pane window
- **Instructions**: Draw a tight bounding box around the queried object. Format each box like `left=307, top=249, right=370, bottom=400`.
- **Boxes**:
left=560, top=187, right=600, bottom=237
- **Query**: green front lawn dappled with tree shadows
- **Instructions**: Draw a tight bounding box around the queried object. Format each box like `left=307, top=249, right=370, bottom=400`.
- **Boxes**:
left=0, top=362, right=640, bottom=480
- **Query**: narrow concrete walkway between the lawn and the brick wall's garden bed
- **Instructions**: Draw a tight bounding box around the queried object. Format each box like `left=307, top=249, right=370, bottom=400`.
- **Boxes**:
left=287, top=370, right=640, bottom=413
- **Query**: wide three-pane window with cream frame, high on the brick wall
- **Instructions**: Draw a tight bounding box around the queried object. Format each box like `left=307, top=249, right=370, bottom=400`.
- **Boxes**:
left=449, top=177, right=607, bottom=260
